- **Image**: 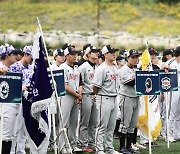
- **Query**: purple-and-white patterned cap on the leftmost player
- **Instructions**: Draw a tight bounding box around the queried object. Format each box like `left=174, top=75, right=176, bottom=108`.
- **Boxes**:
left=0, top=43, right=14, bottom=57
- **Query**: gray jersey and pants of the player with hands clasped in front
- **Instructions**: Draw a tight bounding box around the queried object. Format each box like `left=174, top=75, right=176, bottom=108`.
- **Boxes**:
left=59, top=62, right=79, bottom=150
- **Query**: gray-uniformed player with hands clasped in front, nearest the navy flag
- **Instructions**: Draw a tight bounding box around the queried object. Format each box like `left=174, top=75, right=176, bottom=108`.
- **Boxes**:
left=59, top=46, right=82, bottom=154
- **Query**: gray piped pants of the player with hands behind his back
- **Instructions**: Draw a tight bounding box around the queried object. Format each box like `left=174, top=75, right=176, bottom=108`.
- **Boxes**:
left=96, top=96, right=117, bottom=154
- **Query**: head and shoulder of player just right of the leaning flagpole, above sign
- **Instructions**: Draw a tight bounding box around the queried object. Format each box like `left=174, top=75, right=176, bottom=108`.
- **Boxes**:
left=51, top=49, right=65, bottom=71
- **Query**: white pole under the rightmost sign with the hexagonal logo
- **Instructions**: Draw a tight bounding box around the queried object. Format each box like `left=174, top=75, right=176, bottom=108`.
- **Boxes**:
left=165, top=92, right=170, bottom=148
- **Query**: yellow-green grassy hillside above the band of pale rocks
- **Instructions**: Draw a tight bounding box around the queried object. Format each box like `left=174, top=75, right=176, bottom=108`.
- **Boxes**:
left=0, top=0, right=180, bottom=37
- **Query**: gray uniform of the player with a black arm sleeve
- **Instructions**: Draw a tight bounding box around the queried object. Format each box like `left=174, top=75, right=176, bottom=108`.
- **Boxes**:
left=119, top=64, right=139, bottom=134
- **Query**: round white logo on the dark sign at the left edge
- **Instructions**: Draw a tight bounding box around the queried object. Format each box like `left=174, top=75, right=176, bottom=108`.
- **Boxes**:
left=0, top=81, right=9, bottom=99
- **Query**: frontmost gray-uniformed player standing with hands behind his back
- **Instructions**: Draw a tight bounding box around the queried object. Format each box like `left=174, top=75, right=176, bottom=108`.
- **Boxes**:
left=92, top=45, right=119, bottom=154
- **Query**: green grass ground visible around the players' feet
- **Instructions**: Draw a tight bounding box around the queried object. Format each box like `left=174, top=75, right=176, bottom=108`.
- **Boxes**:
left=25, top=139, right=180, bottom=154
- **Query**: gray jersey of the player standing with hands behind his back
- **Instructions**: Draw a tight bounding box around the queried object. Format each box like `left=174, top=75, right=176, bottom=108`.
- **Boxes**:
left=92, top=62, right=119, bottom=96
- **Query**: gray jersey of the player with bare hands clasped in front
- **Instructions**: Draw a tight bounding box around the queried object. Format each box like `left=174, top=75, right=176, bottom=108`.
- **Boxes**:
left=60, top=62, right=79, bottom=91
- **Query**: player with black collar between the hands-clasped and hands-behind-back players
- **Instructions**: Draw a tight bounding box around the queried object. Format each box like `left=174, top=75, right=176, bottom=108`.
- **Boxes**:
left=78, top=46, right=98, bottom=152
